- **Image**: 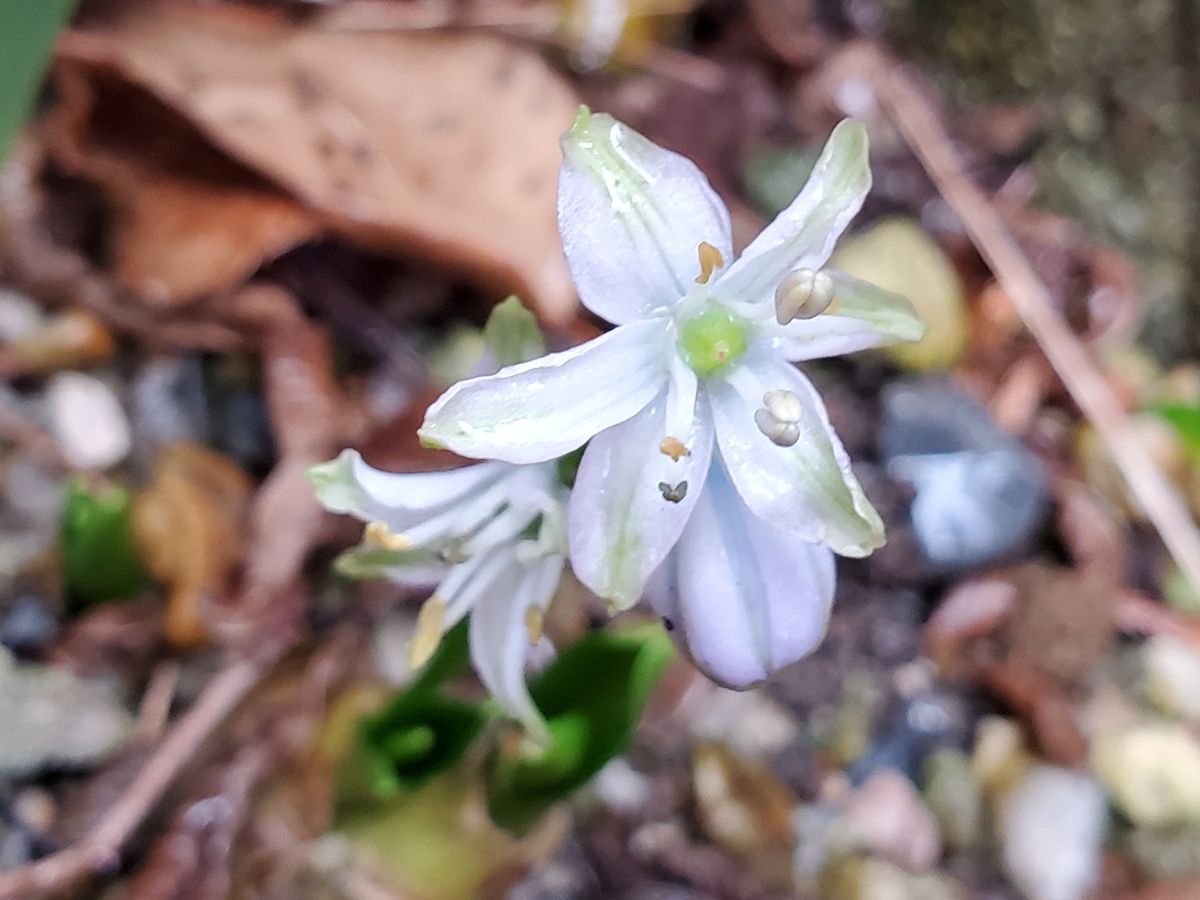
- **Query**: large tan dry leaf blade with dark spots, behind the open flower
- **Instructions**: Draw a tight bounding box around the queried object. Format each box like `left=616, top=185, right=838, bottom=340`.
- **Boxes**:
left=60, top=6, right=577, bottom=323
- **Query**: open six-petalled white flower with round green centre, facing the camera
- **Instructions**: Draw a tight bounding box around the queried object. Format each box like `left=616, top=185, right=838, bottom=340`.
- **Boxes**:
left=421, top=109, right=922, bottom=607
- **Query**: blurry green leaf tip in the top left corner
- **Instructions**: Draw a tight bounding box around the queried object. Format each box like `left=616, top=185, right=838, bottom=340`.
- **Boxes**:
left=0, top=0, right=74, bottom=160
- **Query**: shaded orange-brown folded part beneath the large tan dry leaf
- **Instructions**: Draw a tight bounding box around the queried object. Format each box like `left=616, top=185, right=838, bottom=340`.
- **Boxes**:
left=47, top=63, right=320, bottom=306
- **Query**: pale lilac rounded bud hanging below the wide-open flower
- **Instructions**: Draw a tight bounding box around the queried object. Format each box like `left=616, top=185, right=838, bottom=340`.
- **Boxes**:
left=647, top=462, right=834, bottom=690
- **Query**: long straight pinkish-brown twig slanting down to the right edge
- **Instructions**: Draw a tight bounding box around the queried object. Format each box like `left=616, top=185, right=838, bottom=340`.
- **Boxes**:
left=846, top=44, right=1200, bottom=602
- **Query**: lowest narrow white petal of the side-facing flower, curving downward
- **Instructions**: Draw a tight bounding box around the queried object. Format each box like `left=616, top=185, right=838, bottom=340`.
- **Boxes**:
left=468, top=556, right=564, bottom=740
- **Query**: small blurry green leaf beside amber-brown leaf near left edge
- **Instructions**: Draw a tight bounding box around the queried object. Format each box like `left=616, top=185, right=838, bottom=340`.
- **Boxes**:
left=59, top=480, right=145, bottom=606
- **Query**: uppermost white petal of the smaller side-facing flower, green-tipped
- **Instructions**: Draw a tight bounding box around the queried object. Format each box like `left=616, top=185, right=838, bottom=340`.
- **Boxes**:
left=306, top=450, right=510, bottom=532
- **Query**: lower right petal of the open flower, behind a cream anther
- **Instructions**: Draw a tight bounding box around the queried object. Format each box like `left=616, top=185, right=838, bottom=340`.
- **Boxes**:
left=709, top=350, right=884, bottom=557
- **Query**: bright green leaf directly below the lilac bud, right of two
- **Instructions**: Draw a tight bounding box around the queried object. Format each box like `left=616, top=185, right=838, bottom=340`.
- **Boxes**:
left=488, top=625, right=674, bottom=833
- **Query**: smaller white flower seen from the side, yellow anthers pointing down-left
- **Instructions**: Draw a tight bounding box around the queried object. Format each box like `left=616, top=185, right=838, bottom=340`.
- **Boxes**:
left=308, top=450, right=566, bottom=738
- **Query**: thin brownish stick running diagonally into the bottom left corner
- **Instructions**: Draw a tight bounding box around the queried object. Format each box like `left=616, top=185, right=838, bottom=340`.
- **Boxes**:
left=0, top=661, right=263, bottom=900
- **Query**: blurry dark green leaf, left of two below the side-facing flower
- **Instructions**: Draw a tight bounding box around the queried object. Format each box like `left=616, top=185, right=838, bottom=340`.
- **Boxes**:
left=337, top=686, right=487, bottom=810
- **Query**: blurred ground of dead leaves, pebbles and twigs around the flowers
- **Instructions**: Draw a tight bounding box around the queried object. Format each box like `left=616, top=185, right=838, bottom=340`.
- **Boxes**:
left=0, top=0, right=1200, bottom=900
